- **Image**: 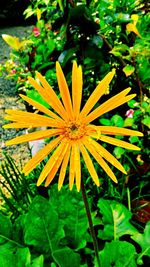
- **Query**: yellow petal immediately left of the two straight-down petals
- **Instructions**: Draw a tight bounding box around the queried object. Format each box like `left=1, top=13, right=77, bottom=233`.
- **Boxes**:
left=58, top=145, right=71, bottom=190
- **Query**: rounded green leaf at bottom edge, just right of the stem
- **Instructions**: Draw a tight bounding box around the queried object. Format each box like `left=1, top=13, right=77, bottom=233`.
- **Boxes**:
left=94, top=240, right=137, bottom=267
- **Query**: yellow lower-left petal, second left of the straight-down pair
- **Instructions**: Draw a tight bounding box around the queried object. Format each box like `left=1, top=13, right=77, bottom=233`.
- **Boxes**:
left=45, top=144, right=68, bottom=186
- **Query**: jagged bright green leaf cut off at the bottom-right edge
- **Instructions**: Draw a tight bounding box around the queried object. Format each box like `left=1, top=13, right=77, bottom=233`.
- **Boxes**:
left=131, top=222, right=150, bottom=265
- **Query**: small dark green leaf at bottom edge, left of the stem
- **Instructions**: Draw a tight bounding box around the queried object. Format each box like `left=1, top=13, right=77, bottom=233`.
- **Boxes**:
left=53, top=247, right=80, bottom=267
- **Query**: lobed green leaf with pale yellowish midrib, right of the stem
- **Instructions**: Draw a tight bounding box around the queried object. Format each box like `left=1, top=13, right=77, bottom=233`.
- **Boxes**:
left=98, top=199, right=137, bottom=240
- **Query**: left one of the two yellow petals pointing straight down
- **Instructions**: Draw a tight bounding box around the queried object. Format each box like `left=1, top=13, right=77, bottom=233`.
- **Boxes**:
left=69, top=144, right=75, bottom=190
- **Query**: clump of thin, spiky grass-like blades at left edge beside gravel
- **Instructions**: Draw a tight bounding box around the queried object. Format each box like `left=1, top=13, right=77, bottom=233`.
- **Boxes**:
left=0, top=154, right=36, bottom=218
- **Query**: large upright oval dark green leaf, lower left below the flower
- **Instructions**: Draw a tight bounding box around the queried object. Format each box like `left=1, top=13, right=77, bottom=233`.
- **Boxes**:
left=24, top=196, right=64, bottom=255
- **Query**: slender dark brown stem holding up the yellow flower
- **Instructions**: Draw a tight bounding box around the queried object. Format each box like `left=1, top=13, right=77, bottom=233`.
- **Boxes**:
left=81, top=180, right=100, bottom=267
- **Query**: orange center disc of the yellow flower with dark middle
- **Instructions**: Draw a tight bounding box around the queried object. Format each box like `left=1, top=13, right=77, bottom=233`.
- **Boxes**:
left=64, top=122, right=86, bottom=140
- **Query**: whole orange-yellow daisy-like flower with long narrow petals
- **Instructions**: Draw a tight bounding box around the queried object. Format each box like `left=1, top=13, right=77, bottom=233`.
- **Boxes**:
left=3, top=62, right=143, bottom=191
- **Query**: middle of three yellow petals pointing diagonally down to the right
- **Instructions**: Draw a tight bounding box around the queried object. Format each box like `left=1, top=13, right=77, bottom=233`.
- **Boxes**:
left=84, top=138, right=118, bottom=183
